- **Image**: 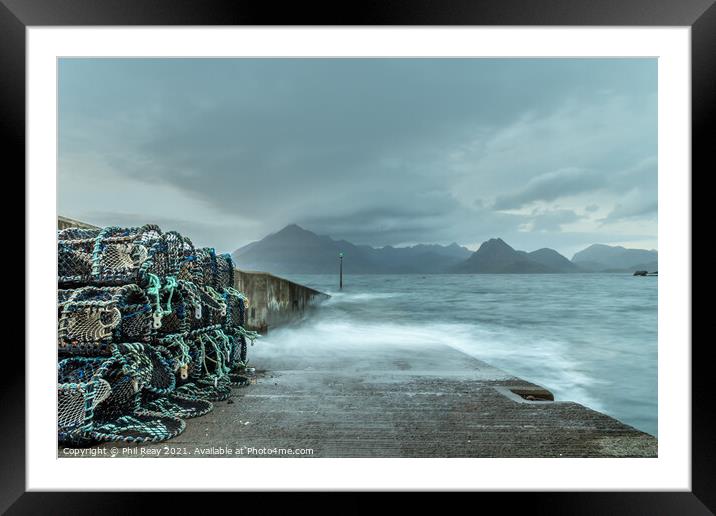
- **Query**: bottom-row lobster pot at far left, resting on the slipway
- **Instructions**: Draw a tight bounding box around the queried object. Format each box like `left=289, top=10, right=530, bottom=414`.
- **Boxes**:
left=57, top=345, right=185, bottom=445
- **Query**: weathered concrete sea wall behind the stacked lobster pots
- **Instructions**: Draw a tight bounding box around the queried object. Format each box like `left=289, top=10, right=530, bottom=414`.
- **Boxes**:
left=57, top=217, right=330, bottom=333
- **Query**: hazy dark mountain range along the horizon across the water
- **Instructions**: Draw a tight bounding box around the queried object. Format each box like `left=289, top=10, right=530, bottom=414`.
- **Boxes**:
left=232, top=224, right=657, bottom=274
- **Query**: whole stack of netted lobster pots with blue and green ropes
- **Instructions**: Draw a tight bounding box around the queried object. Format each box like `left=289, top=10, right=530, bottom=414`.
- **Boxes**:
left=57, top=225, right=257, bottom=445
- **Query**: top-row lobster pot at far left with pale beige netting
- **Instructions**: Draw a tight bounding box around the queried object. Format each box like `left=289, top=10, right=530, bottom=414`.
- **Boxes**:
left=57, top=224, right=184, bottom=285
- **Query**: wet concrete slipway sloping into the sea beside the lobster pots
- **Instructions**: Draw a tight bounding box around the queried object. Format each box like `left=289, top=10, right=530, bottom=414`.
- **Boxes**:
left=77, top=334, right=657, bottom=457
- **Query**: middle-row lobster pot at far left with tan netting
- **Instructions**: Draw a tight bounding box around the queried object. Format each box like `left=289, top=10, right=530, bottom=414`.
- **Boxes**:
left=57, top=285, right=154, bottom=355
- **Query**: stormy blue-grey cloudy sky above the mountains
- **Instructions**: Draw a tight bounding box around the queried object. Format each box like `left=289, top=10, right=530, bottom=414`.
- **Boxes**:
left=58, top=59, right=657, bottom=258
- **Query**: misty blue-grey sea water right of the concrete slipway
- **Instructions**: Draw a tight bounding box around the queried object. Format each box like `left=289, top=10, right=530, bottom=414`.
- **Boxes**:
left=269, top=274, right=658, bottom=435
